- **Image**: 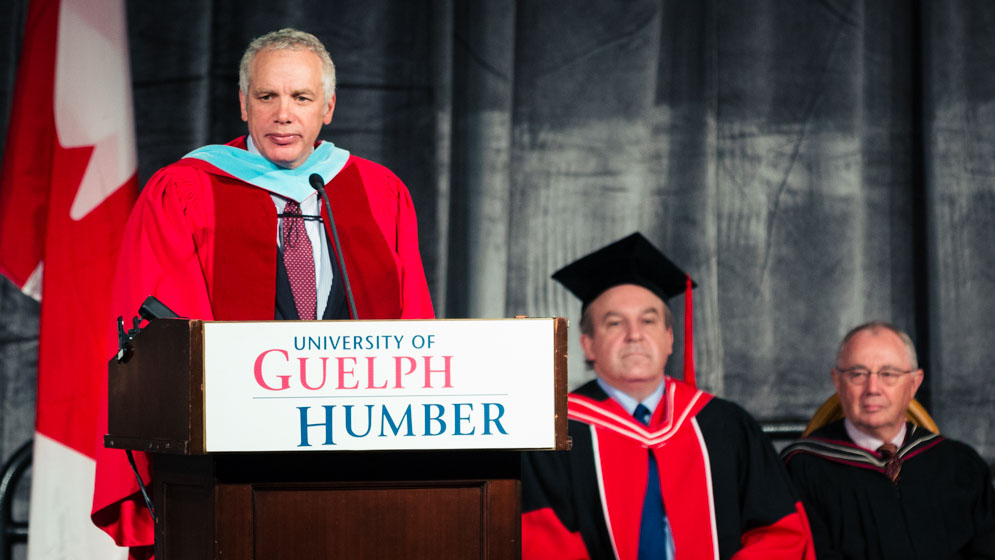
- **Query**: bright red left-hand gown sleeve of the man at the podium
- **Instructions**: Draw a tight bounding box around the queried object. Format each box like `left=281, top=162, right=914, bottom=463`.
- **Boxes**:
left=91, top=166, right=214, bottom=558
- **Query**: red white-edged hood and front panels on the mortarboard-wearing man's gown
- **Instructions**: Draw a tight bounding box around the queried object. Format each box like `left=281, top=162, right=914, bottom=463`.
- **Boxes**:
left=567, top=377, right=718, bottom=558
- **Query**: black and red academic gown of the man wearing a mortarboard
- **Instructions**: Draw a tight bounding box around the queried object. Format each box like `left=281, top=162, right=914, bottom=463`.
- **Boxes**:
left=522, top=377, right=814, bottom=560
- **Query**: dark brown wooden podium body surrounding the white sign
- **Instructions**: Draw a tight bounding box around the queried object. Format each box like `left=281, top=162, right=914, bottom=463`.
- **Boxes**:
left=105, top=318, right=569, bottom=560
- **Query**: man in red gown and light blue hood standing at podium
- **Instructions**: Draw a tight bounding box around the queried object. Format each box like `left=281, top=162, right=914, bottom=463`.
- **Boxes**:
left=92, top=29, right=434, bottom=558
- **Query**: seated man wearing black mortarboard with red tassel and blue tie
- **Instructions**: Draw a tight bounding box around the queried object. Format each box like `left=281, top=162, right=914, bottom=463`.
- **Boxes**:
left=522, top=233, right=811, bottom=560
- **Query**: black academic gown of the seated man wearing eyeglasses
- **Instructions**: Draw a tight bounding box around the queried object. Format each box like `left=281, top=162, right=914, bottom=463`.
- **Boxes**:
left=782, top=420, right=995, bottom=560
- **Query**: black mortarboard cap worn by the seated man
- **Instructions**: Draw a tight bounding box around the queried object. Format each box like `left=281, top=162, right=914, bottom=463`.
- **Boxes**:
left=553, top=232, right=696, bottom=309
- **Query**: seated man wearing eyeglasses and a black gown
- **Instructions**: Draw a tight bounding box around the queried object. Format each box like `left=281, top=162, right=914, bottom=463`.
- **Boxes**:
left=782, top=321, right=995, bottom=560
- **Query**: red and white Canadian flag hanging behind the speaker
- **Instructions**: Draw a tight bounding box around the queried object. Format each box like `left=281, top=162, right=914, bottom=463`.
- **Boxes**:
left=0, top=0, right=138, bottom=560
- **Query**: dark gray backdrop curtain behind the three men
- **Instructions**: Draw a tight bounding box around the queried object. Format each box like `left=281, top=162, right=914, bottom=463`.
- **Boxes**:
left=0, top=0, right=995, bottom=524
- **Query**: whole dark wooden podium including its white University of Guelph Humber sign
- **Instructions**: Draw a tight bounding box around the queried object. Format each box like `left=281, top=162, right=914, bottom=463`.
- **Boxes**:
left=104, top=317, right=570, bottom=560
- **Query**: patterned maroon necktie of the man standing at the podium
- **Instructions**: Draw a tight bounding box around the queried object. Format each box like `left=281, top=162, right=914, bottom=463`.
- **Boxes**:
left=280, top=200, right=318, bottom=320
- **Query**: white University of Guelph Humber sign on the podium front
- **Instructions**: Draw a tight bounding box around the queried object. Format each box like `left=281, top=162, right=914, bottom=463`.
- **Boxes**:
left=203, top=319, right=557, bottom=452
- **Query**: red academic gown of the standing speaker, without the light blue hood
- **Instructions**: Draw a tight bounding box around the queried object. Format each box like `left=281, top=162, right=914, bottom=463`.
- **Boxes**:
left=92, top=137, right=434, bottom=558
